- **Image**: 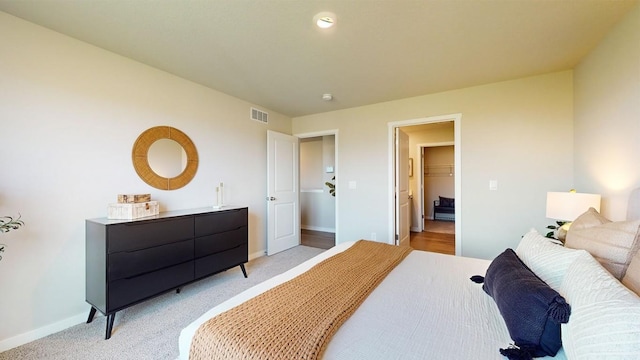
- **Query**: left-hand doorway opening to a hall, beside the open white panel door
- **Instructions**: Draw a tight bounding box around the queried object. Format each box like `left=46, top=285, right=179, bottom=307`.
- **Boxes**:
left=296, top=131, right=338, bottom=249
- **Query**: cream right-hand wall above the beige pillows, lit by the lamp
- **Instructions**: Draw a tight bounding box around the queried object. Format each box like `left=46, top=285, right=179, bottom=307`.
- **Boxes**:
left=573, top=5, right=640, bottom=220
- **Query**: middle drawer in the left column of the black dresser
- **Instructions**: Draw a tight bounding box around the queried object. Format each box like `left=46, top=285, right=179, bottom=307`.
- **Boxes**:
left=108, top=239, right=193, bottom=281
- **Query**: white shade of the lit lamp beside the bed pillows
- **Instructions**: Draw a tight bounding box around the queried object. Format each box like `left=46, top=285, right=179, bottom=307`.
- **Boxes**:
left=547, top=192, right=600, bottom=221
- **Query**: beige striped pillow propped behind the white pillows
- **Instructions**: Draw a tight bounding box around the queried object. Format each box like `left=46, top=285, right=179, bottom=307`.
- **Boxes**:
left=565, top=208, right=640, bottom=280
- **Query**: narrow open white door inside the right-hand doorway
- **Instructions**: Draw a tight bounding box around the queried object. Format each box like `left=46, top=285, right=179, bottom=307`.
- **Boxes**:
left=394, top=128, right=411, bottom=246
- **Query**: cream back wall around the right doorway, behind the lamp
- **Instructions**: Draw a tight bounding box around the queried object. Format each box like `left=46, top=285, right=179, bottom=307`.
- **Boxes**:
left=293, top=71, right=573, bottom=259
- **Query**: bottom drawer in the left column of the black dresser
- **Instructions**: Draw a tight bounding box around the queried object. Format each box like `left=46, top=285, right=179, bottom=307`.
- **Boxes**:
left=107, top=261, right=193, bottom=312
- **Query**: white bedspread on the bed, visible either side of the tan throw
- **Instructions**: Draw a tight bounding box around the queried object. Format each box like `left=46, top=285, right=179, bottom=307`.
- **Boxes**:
left=179, top=242, right=565, bottom=360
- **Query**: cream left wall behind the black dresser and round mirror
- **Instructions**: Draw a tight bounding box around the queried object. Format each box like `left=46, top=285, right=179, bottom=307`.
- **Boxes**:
left=0, top=12, right=291, bottom=351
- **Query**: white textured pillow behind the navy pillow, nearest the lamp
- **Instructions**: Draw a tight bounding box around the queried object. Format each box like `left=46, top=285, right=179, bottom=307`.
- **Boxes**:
left=516, top=229, right=586, bottom=291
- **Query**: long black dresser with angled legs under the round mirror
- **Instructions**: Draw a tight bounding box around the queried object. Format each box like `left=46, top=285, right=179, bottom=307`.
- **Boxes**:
left=86, top=207, right=249, bottom=339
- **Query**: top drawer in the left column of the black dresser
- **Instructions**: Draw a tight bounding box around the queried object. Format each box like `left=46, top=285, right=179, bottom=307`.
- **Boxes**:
left=107, top=216, right=193, bottom=254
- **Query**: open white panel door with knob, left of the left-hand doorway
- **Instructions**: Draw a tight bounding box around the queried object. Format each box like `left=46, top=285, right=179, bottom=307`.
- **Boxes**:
left=267, top=131, right=300, bottom=255
